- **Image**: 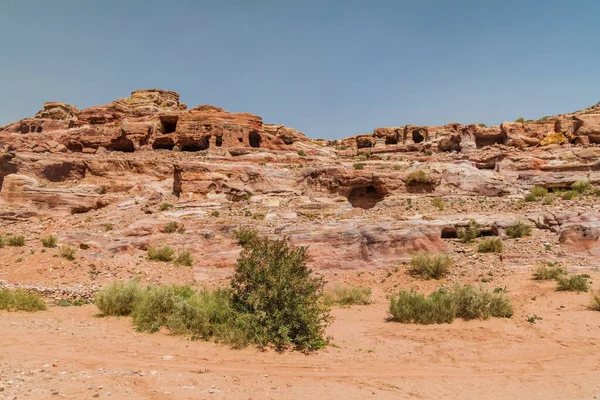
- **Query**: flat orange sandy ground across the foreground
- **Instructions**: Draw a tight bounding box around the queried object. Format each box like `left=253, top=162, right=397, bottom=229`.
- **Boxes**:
left=0, top=281, right=600, bottom=399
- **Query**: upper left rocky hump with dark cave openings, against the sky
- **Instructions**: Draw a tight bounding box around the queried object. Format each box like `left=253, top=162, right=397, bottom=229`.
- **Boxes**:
left=0, top=89, right=310, bottom=153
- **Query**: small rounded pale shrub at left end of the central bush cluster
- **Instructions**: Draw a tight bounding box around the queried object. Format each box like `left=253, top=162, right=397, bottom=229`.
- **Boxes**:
left=94, top=280, right=142, bottom=316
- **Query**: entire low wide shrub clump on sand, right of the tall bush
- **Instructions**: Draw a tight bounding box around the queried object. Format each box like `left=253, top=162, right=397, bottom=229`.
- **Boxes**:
left=390, top=284, right=513, bottom=324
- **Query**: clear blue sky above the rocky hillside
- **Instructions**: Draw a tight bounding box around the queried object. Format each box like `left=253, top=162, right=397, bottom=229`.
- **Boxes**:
left=0, top=0, right=600, bottom=139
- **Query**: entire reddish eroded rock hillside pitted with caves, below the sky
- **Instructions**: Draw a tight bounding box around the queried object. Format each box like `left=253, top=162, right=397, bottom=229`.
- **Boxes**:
left=0, top=89, right=600, bottom=277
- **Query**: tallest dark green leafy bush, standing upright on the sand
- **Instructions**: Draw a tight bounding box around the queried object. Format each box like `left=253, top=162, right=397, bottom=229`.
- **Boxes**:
left=231, top=239, right=330, bottom=350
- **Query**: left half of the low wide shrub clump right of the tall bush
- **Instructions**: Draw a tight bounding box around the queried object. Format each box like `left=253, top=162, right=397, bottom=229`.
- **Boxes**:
left=390, top=290, right=456, bottom=324
